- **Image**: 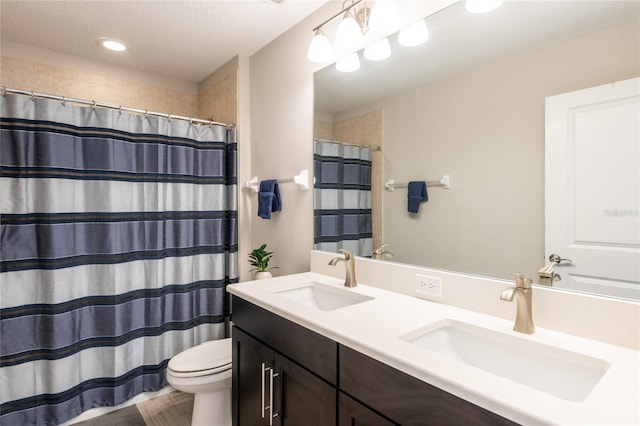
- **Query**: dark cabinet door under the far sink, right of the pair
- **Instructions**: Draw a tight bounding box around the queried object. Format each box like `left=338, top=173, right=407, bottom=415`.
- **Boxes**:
left=274, top=352, right=337, bottom=426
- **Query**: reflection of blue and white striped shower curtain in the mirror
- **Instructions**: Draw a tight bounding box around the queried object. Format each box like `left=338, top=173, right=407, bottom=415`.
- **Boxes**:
left=314, top=140, right=373, bottom=256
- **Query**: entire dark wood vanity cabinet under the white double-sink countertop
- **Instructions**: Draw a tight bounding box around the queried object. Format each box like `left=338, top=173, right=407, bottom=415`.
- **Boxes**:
left=232, top=297, right=515, bottom=426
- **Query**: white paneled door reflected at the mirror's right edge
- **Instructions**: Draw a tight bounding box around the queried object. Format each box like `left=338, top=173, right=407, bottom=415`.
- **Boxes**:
left=545, top=78, right=640, bottom=300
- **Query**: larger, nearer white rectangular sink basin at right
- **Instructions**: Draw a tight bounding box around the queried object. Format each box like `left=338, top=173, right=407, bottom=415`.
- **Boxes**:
left=400, top=320, right=610, bottom=402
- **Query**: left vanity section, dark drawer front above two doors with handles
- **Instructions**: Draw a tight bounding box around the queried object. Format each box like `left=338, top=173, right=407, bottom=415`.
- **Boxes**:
left=232, top=298, right=337, bottom=426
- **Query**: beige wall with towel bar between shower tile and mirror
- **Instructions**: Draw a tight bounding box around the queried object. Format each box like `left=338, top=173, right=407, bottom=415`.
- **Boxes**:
left=248, top=8, right=322, bottom=278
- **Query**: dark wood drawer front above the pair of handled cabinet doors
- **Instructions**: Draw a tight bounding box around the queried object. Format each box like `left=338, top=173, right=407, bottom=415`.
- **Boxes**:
left=232, top=297, right=338, bottom=385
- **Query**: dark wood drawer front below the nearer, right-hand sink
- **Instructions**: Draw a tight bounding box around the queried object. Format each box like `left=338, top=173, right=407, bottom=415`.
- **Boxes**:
left=339, top=345, right=516, bottom=426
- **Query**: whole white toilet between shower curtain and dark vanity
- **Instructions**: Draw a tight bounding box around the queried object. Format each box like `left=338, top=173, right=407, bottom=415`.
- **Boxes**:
left=167, top=339, right=231, bottom=426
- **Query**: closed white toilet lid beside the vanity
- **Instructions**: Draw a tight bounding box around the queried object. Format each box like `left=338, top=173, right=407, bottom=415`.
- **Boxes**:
left=168, top=339, right=231, bottom=373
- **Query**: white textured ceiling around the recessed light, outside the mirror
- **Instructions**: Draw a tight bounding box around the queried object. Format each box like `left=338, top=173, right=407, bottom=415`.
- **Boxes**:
left=0, top=0, right=327, bottom=83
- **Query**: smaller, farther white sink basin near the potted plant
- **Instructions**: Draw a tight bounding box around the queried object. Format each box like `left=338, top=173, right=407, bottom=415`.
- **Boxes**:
left=274, top=281, right=373, bottom=311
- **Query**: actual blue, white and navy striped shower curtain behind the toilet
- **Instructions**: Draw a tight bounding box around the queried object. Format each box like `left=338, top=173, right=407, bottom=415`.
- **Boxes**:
left=0, top=95, right=238, bottom=425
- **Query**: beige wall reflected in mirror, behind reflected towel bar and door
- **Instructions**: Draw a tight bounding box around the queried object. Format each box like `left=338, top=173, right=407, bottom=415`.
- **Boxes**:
left=356, top=22, right=640, bottom=278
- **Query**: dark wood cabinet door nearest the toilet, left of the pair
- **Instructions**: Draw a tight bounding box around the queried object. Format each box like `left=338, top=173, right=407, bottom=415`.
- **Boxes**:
left=232, top=328, right=273, bottom=426
